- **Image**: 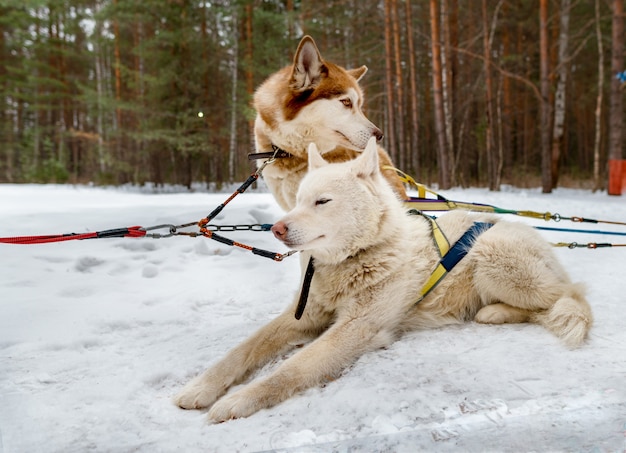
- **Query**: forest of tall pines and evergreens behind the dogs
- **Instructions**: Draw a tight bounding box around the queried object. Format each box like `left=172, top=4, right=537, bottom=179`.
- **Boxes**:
left=0, top=0, right=626, bottom=192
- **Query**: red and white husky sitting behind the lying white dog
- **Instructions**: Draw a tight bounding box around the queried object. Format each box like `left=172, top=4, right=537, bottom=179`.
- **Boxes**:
left=246, top=36, right=406, bottom=211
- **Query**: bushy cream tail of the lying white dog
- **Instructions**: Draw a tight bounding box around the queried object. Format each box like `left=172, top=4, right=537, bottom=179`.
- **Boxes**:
left=532, top=285, right=593, bottom=348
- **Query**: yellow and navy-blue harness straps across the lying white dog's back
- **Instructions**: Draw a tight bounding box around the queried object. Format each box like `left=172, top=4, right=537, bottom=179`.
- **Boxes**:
left=409, top=210, right=493, bottom=306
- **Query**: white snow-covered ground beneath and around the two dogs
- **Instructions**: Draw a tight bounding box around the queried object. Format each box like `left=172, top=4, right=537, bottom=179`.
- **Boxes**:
left=0, top=185, right=626, bottom=453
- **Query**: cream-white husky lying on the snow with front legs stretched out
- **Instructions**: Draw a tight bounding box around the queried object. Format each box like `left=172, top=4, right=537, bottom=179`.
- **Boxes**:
left=175, top=139, right=592, bottom=422
